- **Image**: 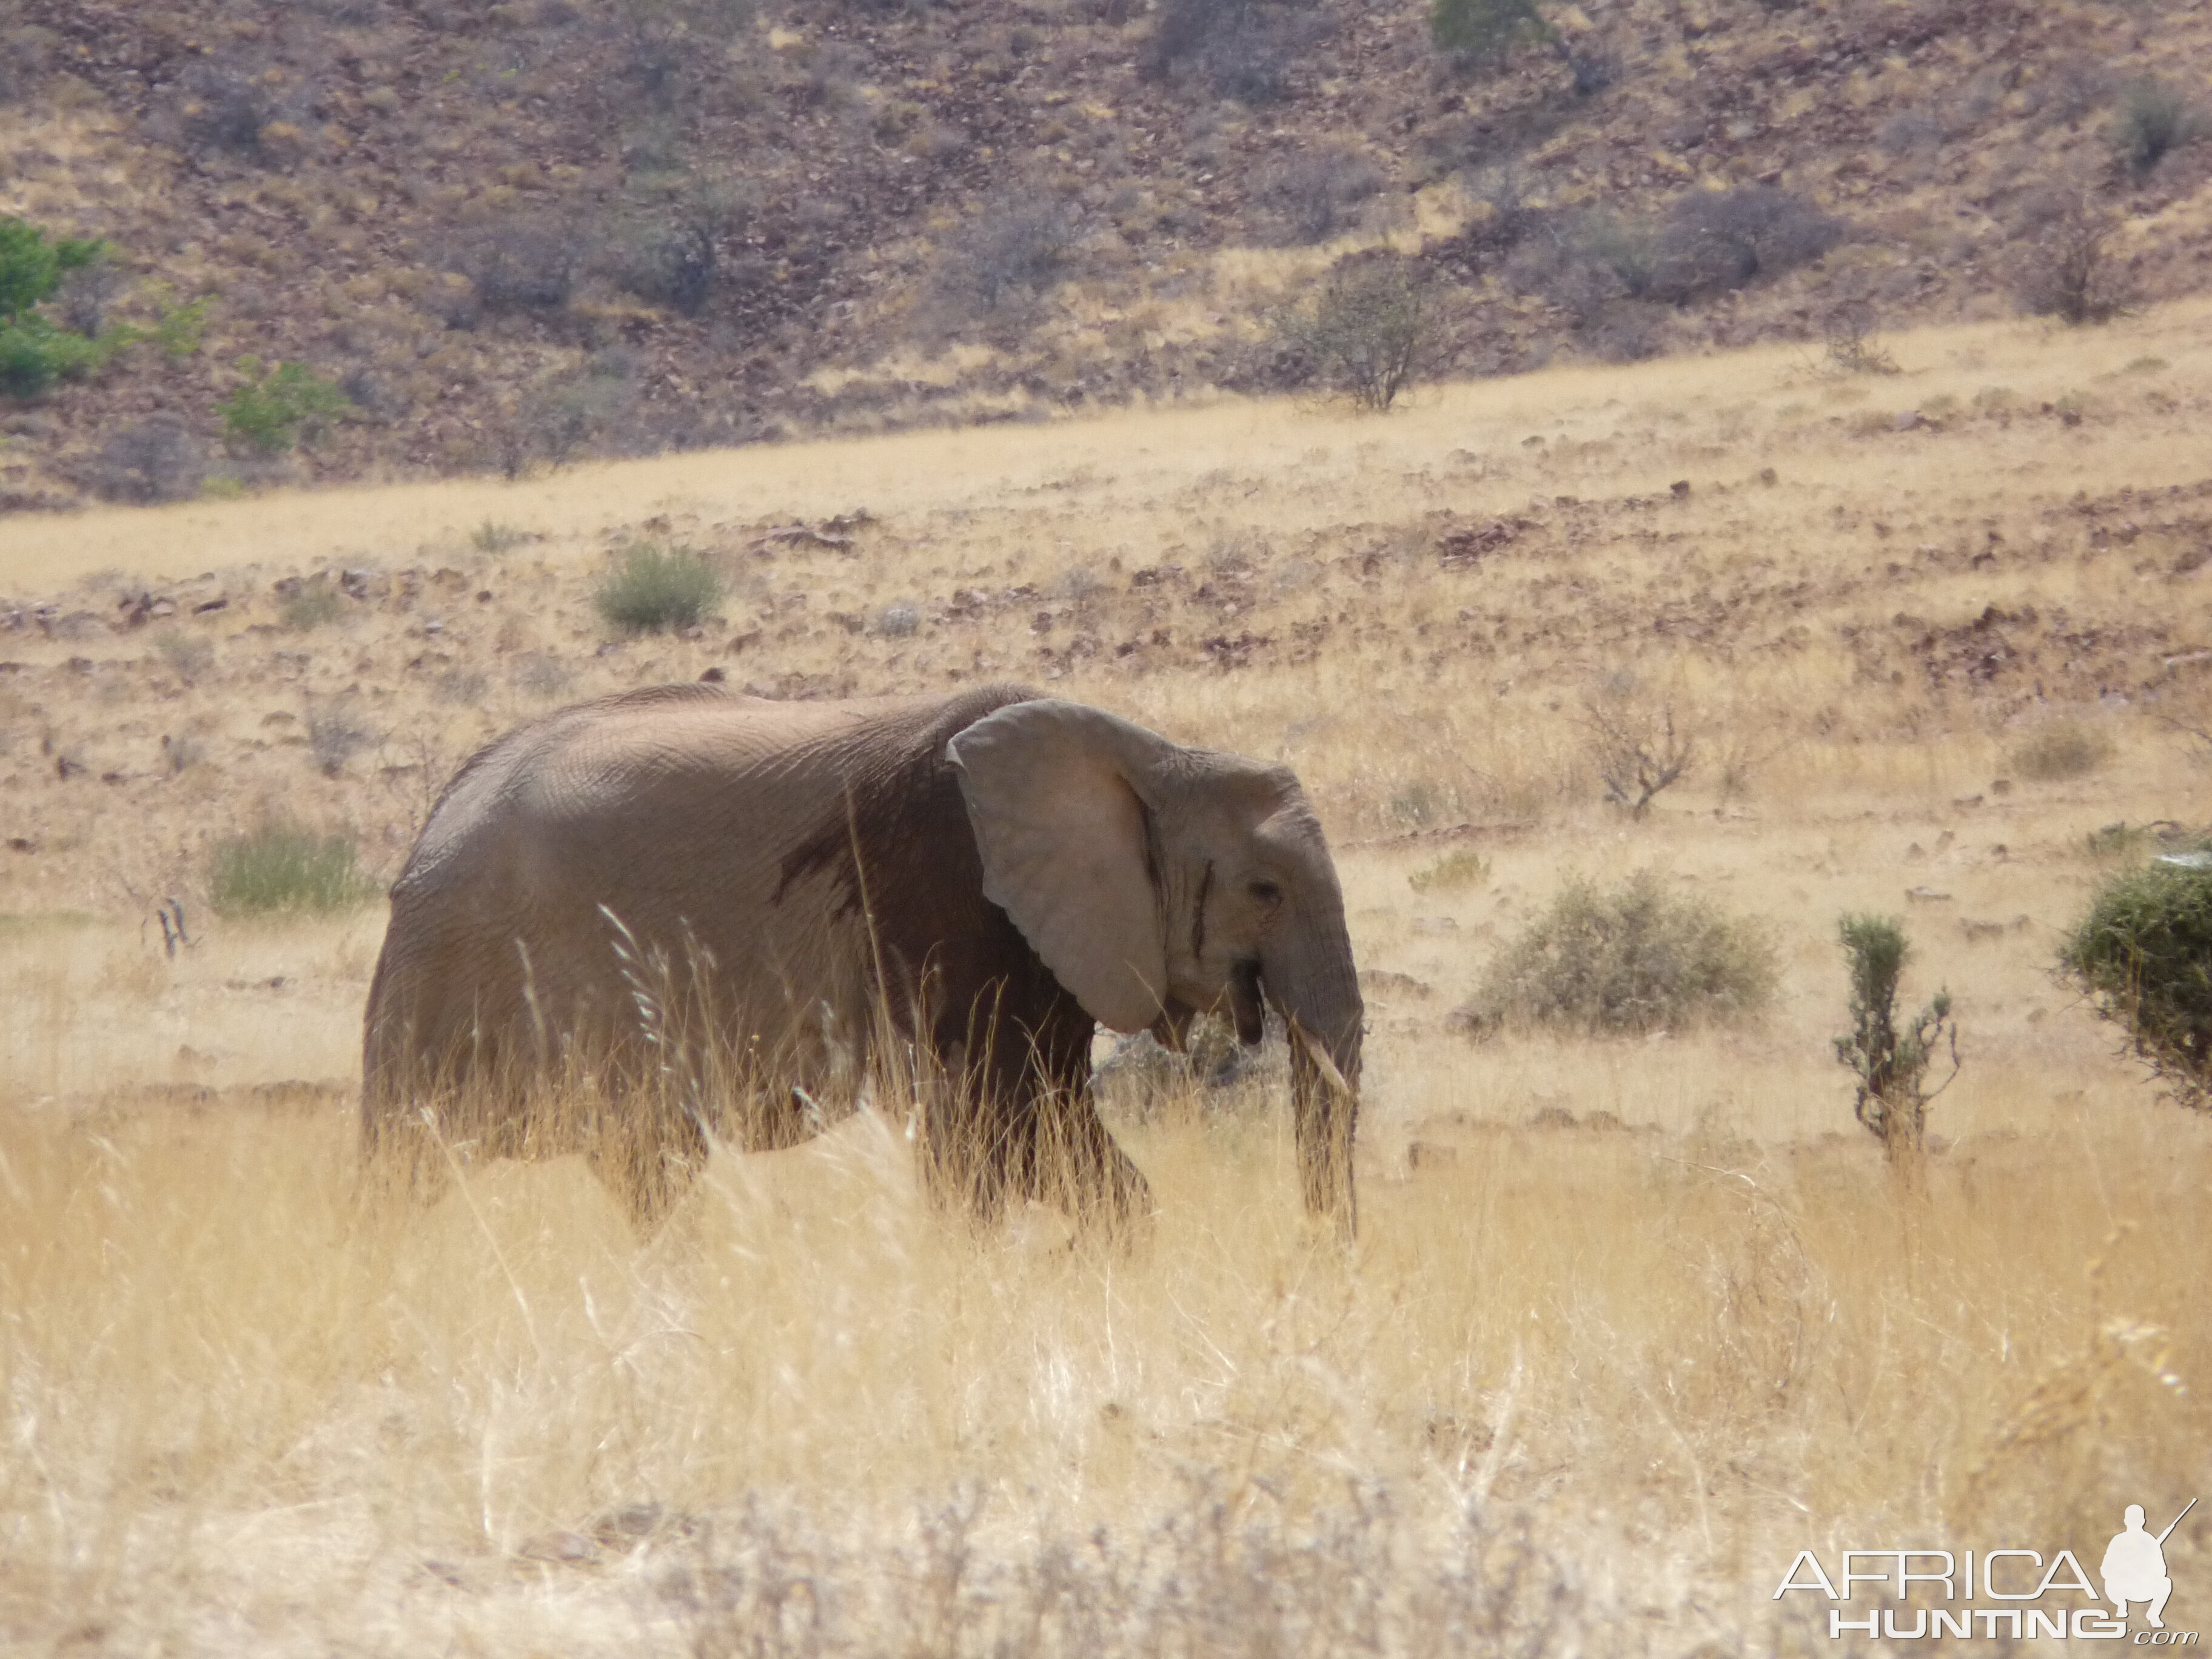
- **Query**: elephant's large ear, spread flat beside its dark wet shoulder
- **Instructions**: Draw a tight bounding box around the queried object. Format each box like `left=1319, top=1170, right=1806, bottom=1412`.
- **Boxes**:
left=945, top=697, right=1172, bottom=1031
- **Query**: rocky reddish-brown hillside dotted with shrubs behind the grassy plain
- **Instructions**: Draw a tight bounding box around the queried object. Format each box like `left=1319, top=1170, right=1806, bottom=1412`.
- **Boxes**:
left=0, top=0, right=2212, bottom=509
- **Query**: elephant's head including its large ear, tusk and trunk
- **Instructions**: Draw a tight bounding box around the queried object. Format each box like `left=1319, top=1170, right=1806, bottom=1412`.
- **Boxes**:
left=945, top=697, right=1362, bottom=1232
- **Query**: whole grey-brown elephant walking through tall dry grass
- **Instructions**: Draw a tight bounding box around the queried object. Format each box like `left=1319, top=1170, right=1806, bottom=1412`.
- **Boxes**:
left=361, top=683, right=1362, bottom=1236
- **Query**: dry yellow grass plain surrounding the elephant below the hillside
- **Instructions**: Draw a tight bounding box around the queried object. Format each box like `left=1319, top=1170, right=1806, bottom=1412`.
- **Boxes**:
left=0, top=307, right=2212, bottom=1655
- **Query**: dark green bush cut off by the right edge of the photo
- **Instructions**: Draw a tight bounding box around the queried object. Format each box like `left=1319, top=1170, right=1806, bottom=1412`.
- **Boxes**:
left=2059, top=863, right=2212, bottom=1106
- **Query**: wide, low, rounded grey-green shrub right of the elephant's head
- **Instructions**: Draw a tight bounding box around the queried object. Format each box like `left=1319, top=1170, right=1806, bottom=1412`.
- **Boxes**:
left=1471, top=870, right=1774, bottom=1035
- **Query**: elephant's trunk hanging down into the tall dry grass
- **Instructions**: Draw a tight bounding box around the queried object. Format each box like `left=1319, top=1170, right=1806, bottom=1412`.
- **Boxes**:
left=1261, top=937, right=1367, bottom=1239
